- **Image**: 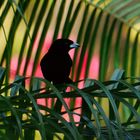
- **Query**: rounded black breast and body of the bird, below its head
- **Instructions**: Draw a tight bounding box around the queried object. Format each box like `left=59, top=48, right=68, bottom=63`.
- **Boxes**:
left=41, top=54, right=72, bottom=83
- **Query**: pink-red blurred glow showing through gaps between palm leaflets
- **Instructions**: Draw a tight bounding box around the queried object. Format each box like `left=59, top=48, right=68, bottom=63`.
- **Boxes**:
left=10, top=34, right=99, bottom=121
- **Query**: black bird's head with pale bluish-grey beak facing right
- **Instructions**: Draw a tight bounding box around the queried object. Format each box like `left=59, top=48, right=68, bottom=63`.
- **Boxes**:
left=50, top=39, right=80, bottom=53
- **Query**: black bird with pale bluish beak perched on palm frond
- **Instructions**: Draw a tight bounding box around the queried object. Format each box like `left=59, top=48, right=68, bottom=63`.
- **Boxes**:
left=40, top=39, right=79, bottom=85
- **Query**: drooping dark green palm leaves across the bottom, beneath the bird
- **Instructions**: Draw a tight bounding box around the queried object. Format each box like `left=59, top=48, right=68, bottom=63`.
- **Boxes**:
left=0, top=68, right=140, bottom=140
